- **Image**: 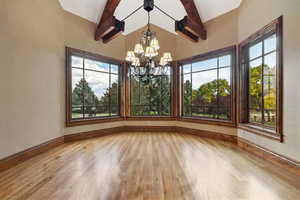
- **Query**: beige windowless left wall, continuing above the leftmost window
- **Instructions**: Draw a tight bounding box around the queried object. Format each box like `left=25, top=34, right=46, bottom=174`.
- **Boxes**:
left=0, top=0, right=125, bottom=159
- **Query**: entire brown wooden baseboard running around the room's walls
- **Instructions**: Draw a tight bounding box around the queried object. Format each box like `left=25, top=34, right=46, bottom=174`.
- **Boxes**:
left=4, top=126, right=300, bottom=176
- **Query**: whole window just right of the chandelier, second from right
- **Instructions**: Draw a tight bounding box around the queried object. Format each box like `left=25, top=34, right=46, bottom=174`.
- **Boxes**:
left=181, top=47, right=235, bottom=122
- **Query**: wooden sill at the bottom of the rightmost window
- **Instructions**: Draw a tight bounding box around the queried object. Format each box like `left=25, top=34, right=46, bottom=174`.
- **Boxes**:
left=238, top=124, right=283, bottom=142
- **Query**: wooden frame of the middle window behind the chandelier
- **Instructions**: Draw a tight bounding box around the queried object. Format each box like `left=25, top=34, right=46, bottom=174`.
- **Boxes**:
left=124, top=62, right=177, bottom=121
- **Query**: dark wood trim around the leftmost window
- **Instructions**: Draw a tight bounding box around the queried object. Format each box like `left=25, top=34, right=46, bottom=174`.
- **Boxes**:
left=66, top=47, right=124, bottom=127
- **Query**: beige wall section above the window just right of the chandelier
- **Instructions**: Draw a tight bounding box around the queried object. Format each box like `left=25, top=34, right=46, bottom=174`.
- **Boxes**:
left=176, top=9, right=238, bottom=60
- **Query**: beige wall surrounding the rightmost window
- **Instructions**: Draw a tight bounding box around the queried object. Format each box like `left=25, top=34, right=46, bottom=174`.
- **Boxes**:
left=238, top=0, right=300, bottom=161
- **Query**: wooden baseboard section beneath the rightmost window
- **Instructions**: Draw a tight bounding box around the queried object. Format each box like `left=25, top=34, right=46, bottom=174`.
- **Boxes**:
left=238, top=138, right=300, bottom=176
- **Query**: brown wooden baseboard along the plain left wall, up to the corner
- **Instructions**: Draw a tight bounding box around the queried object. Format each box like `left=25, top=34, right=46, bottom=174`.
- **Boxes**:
left=0, top=137, right=64, bottom=172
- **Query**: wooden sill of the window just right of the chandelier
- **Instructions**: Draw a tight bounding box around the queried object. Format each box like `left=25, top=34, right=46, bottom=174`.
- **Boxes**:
left=179, top=117, right=236, bottom=127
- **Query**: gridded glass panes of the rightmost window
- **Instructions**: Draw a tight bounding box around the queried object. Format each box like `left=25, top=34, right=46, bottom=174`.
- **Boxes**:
left=248, top=34, right=277, bottom=128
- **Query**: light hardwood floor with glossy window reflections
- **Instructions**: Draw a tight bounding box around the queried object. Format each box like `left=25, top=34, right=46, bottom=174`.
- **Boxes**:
left=0, top=133, right=300, bottom=200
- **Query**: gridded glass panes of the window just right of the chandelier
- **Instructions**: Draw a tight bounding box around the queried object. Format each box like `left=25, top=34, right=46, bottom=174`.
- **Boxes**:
left=181, top=54, right=232, bottom=120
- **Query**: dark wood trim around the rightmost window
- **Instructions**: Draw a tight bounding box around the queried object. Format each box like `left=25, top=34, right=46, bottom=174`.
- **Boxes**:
left=238, top=16, right=283, bottom=142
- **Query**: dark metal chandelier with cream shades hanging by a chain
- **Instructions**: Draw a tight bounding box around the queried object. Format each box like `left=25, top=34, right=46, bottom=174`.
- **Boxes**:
left=125, top=0, right=172, bottom=76
